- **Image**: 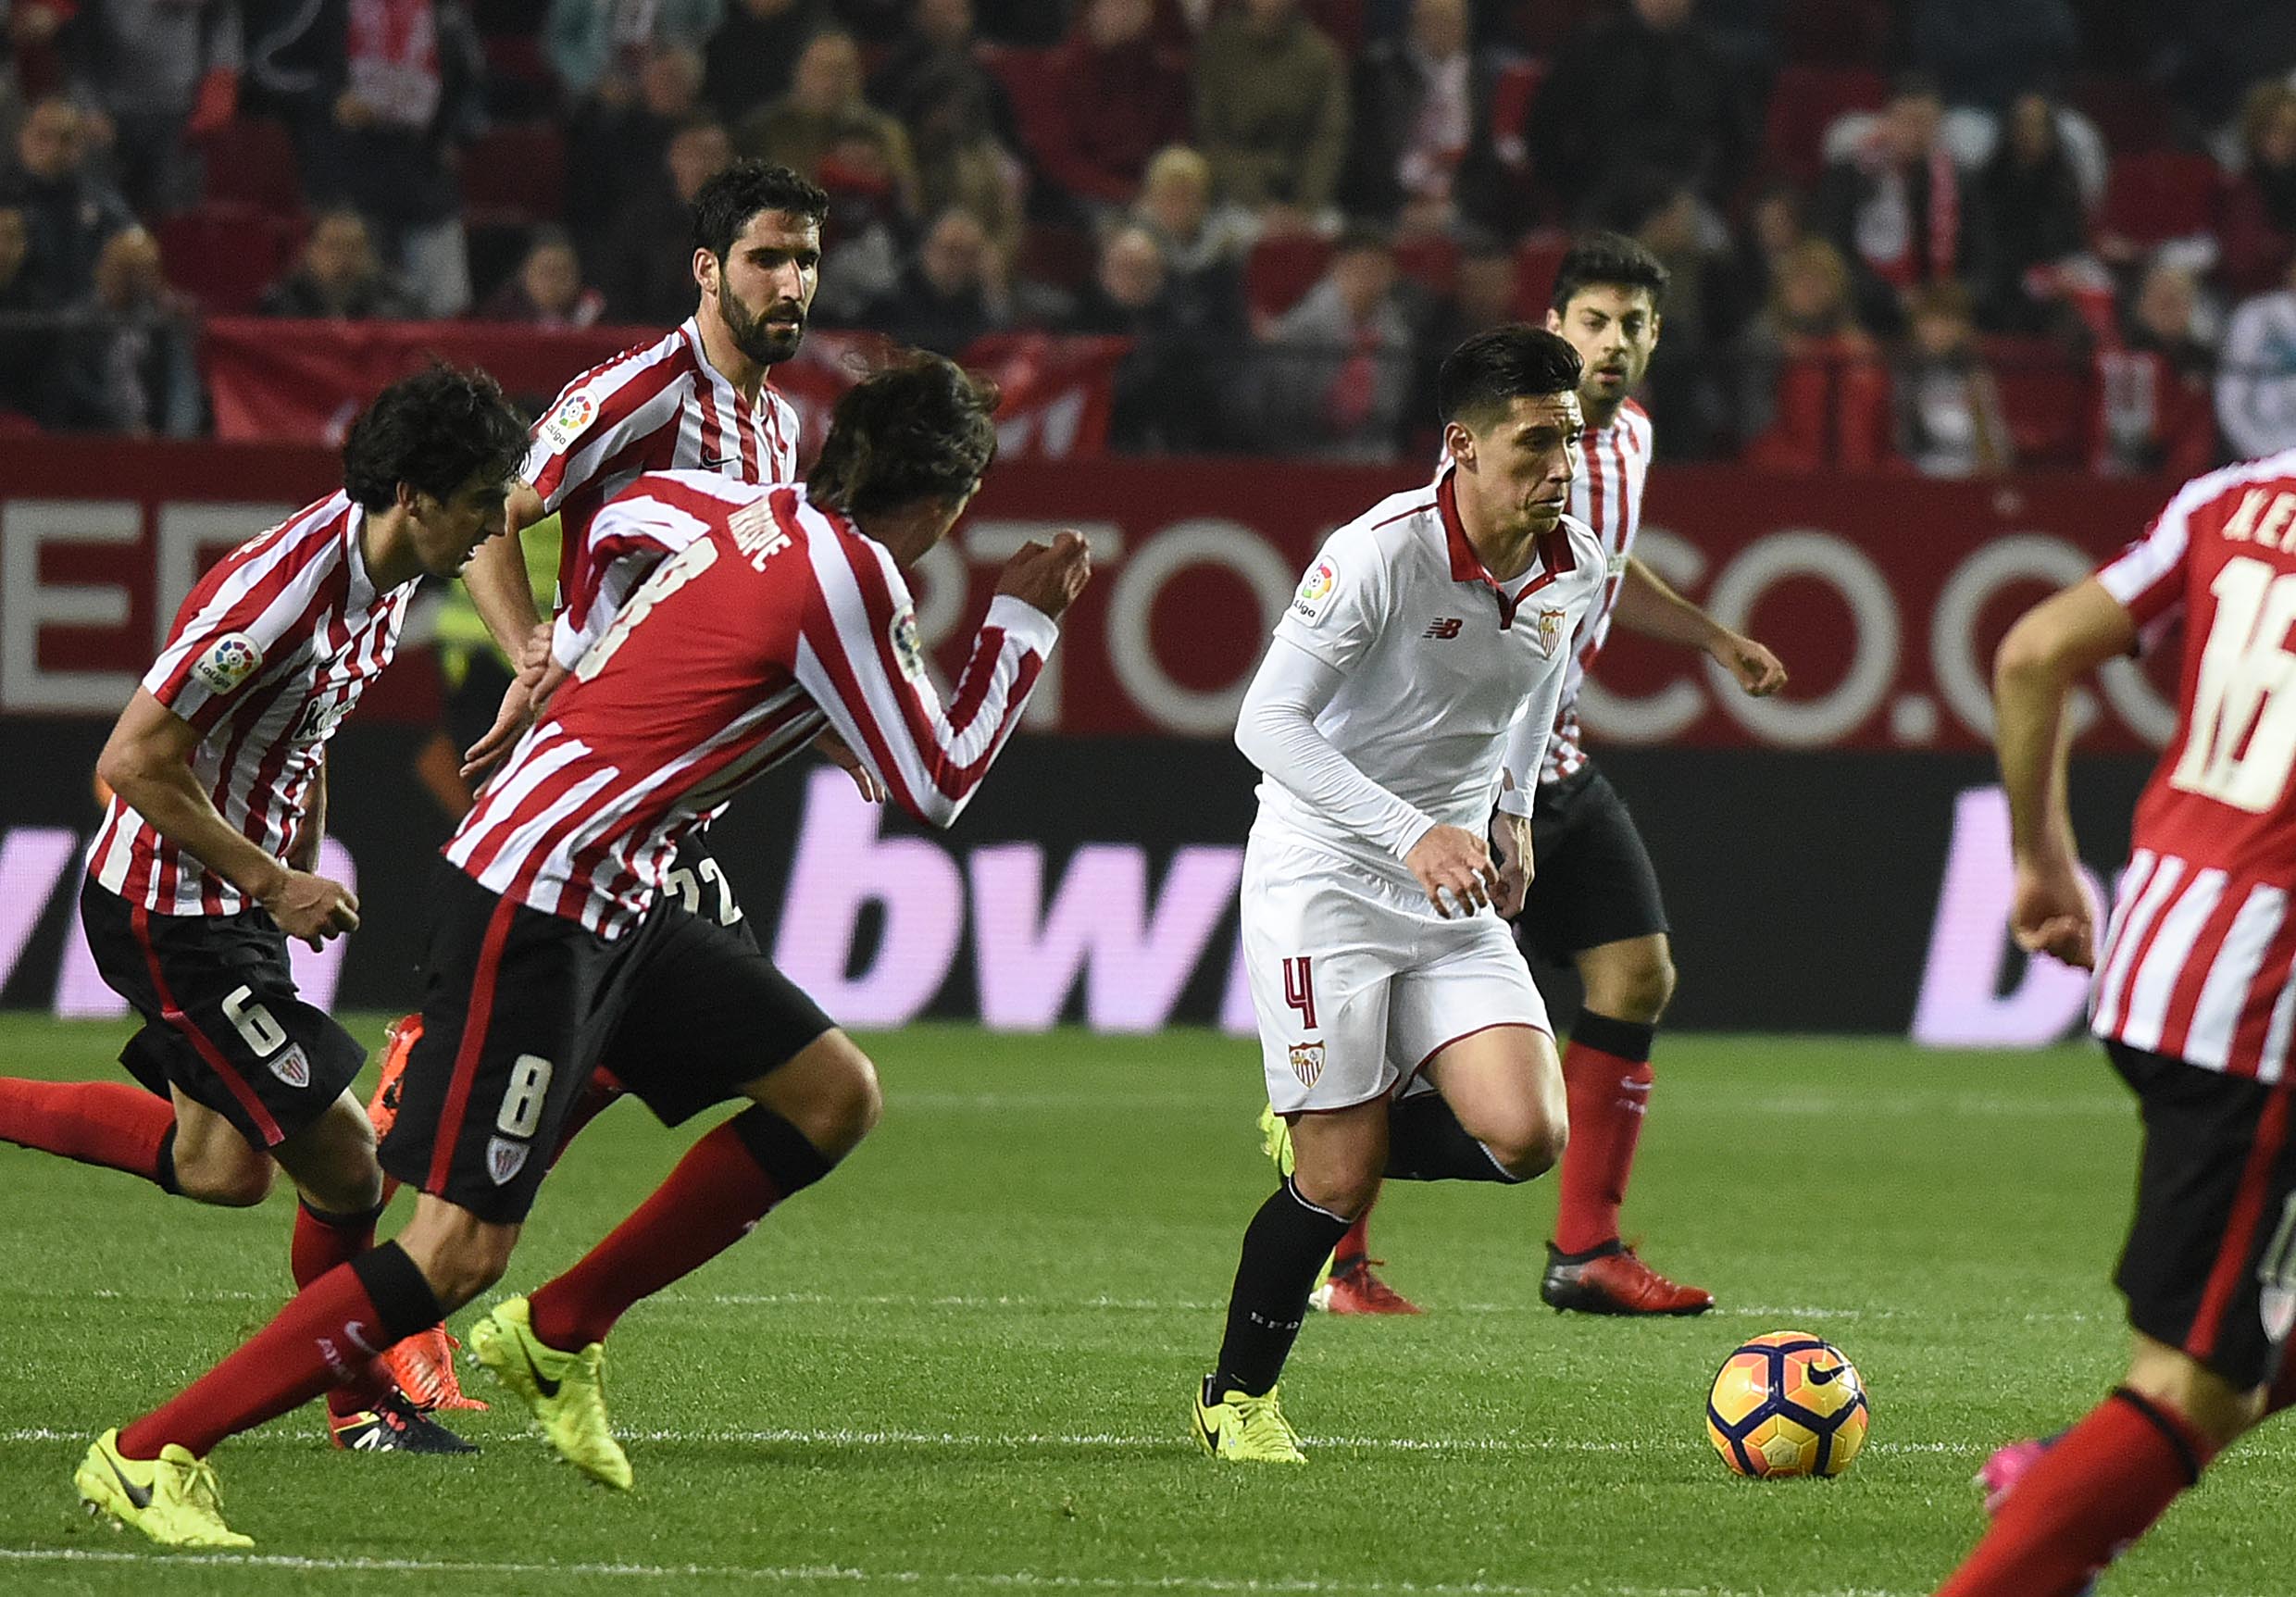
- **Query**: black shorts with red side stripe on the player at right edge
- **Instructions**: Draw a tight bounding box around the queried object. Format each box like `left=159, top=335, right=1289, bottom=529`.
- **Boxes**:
left=2105, top=1042, right=2296, bottom=1391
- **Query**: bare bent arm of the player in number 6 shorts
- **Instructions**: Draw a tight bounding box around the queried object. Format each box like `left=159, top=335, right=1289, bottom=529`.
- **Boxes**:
left=96, top=689, right=358, bottom=948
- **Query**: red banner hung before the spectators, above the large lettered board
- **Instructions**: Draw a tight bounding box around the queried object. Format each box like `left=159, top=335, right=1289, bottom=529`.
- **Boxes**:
left=202, top=317, right=1125, bottom=459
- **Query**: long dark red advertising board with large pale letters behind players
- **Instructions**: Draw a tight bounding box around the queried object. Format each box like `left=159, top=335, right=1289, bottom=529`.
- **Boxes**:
left=0, top=440, right=2175, bottom=750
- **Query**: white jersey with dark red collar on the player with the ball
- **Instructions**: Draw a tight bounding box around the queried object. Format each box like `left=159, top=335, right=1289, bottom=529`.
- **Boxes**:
left=1254, top=470, right=1607, bottom=881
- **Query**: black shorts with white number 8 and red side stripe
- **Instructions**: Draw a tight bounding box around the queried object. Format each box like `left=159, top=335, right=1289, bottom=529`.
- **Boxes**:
left=383, top=860, right=831, bottom=1223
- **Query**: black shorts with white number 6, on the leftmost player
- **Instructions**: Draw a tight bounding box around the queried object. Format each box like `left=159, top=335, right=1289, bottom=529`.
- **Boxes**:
left=81, top=877, right=368, bottom=1150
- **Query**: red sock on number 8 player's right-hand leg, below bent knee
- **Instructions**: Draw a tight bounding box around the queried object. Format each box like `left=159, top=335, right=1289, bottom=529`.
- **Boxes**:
left=530, top=1119, right=780, bottom=1352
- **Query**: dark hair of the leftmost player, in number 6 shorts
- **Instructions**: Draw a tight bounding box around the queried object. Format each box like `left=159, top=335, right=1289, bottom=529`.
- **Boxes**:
left=343, top=365, right=526, bottom=509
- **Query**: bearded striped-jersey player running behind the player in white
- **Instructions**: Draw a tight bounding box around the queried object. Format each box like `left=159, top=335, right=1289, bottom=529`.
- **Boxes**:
left=1267, top=234, right=1786, bottom=1315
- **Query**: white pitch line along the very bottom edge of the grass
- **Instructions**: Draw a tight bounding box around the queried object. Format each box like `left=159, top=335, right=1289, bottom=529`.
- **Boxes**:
left=0, top=1546, right=1915, bottom=1597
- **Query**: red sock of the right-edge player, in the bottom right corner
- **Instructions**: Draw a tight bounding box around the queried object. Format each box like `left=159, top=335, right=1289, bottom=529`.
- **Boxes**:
left=1938, top=1388, right=2215, bottom=1597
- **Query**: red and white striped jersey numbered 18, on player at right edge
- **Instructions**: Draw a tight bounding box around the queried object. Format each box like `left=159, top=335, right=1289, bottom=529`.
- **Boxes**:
left=2090, top=450, right=2296, bottom=1080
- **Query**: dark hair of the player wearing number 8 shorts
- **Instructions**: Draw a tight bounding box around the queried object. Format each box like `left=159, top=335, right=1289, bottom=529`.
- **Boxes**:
left=805, top=349, right=999, bottom=517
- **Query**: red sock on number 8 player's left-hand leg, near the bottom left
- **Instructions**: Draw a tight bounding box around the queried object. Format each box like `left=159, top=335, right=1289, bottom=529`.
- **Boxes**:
left=119, top=1246, right=439, bottom=1459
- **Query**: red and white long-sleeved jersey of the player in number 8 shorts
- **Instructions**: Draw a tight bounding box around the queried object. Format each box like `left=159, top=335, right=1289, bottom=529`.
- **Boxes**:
left=445, top=470, right=1058, bottom=936
